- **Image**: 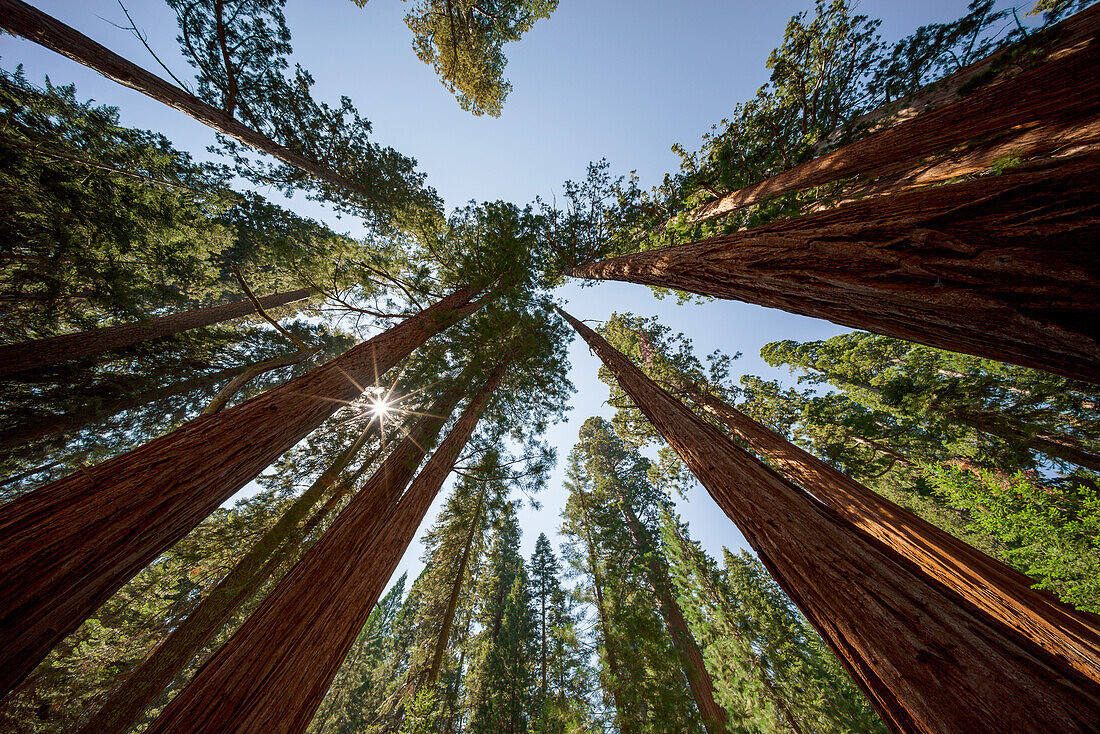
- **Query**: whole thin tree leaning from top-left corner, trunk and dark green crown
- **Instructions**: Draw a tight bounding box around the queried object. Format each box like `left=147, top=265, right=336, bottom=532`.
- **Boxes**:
left=0, top=0, right=432, bottom=224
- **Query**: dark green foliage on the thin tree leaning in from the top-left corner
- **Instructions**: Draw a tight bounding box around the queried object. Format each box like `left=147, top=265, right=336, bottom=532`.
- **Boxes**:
left=168, top=0, right=438, bottom=226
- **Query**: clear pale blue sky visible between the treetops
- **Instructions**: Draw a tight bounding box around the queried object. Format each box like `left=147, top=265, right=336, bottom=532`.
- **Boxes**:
left=0, top=0, right=998, bottom=574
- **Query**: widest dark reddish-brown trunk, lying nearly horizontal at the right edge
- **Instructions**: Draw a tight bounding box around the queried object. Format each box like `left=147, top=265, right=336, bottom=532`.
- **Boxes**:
left=571, top=154, right=1100, bottom=382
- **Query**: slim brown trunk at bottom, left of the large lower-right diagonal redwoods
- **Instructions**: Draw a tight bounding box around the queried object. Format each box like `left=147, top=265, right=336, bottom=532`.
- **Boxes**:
left=615, top=486, right=727, bottom=734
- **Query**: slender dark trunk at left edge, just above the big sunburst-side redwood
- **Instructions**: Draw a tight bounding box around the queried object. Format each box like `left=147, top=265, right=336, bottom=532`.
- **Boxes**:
left=0, top=364, right=250, bottom=453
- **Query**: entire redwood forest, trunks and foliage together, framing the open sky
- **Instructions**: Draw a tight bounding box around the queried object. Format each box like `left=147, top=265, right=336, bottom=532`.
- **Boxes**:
left=0, top=0, right=1100, bottom=734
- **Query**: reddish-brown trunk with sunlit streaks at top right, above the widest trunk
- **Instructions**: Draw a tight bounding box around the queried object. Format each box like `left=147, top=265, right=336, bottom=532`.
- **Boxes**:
left=673, top=7, right=1100, bottom=223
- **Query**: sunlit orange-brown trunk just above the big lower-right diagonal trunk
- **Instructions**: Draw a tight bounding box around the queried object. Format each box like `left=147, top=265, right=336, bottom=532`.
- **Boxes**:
left=681, top=384, right=1100, bottom=683
